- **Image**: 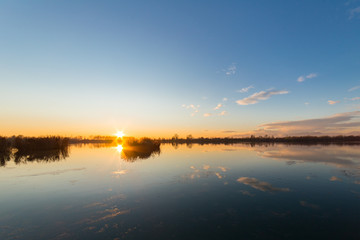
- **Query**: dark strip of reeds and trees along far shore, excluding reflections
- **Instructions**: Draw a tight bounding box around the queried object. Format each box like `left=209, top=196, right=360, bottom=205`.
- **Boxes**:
left=0, top=134, right=360, bottom=147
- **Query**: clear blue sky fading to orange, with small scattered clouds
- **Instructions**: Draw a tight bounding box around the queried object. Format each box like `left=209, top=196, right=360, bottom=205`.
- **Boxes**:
left=0, top=0, right=360, bottom=137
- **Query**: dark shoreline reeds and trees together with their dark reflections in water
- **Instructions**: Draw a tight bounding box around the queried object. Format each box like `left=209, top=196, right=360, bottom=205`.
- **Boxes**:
left=0, top=134, right=360, bottom=166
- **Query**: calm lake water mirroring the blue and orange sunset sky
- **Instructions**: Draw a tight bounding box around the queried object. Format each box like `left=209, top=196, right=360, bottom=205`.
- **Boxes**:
left=0, top=145, right=360, bottom=239
